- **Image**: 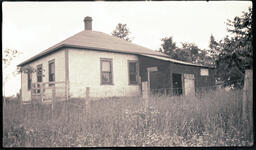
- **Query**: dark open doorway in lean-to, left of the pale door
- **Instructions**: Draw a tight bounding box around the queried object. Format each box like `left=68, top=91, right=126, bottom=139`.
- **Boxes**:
left=172, top=73, right=182, bottom=96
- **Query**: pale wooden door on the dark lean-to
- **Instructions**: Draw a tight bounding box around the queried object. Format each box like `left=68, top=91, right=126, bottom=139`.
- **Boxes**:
left=184, top=74, right=195, bottom=95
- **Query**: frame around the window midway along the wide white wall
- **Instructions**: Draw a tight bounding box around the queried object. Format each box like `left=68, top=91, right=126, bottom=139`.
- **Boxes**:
left=100, top=58, right=114, bottom=85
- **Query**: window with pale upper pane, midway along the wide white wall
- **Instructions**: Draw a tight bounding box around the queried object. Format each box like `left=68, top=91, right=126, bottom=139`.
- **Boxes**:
left=100, top=58, right=113, bottom=84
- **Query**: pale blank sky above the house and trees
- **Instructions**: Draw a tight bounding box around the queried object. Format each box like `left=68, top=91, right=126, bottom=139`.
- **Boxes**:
left=2, top=1, right=252, bottom=95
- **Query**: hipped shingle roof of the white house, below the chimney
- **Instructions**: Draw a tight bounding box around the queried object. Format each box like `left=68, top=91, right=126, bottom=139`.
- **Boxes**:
left=18, top=30, right=168, bottom=66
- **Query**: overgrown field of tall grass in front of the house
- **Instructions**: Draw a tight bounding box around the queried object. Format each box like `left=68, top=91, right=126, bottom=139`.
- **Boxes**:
left=3, top=90, right=253, bottom=147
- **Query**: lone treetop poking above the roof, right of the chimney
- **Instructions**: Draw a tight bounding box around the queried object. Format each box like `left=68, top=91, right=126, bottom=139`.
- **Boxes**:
left=111, top=23, right=131, bottom=42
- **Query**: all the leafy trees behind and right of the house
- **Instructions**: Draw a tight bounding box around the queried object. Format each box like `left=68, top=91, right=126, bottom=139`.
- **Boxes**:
left=112, top=7, right=253, bottom=88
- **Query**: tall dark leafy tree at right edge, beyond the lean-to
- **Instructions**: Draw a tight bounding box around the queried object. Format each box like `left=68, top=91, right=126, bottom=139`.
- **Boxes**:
left=216, top=8, right=253, bottom=88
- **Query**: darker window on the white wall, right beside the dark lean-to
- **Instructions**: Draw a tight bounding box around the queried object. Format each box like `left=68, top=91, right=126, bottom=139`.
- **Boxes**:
left=128, top=61, right=138, bottom=84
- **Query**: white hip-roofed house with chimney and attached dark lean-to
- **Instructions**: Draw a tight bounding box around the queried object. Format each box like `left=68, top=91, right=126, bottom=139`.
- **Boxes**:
left=18, top=17, right=215, bottom=101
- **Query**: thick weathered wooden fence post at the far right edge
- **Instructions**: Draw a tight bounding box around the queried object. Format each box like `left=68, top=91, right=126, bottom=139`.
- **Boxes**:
left=242, top=69, right=253, bottom=138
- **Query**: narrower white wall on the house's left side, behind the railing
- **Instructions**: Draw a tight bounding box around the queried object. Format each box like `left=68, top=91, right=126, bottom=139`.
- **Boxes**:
left=21, top=50, right=65, bottom=101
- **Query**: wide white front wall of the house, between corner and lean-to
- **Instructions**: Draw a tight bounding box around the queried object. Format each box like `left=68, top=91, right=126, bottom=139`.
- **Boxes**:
left=68, top=49, right=140, bottom=98
